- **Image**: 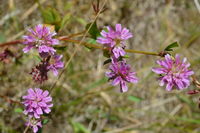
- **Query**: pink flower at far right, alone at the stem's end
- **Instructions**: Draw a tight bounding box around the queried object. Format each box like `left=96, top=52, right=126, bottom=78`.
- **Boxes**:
left=152, top=54, right=194, bottom=91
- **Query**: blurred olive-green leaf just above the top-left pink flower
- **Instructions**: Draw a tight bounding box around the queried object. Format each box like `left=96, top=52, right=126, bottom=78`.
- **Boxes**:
left=41, top=7, right=61, bottom=31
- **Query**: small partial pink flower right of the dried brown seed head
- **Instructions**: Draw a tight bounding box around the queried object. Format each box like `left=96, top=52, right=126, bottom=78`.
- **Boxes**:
left=48, top=55, right=64, bottom=76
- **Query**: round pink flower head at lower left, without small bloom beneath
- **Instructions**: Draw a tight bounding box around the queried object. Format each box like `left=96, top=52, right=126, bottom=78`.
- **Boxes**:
left=22, top=88, right=53, bottom=119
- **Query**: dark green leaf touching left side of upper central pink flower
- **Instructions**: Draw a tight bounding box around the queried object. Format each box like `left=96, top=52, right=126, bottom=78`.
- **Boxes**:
left=86, top=22, right=100, bottom=40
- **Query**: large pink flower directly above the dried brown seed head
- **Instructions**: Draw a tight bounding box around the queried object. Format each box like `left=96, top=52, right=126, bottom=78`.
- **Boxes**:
left=23, top=24, right=59, bottom=54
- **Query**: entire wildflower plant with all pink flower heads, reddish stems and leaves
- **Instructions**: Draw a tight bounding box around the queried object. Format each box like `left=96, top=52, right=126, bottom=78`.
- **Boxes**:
left=0, top=1, right=200, bottom=133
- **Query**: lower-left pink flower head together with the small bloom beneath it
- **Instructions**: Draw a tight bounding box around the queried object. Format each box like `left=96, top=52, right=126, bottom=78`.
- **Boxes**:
left=22, top=88, right=53, bottom=133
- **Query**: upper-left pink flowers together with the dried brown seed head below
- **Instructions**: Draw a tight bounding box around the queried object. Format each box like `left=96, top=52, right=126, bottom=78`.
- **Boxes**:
left=23, top=24, right=64, bottom=83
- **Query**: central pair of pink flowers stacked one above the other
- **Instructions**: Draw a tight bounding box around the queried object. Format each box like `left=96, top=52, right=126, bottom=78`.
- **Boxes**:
left=97, top=24, right=138, bottom=92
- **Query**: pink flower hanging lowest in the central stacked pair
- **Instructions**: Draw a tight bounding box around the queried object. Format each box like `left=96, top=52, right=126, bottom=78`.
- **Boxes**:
left=106, top=61, right=138, bottom=92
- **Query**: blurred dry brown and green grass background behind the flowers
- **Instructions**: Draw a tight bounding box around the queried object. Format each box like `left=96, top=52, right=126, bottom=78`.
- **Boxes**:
left=0, top=0, right=200, bottom=133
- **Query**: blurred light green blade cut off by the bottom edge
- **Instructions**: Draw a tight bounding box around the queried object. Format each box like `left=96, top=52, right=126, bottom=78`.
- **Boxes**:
left=71, top=122, right=90, bottom=133
